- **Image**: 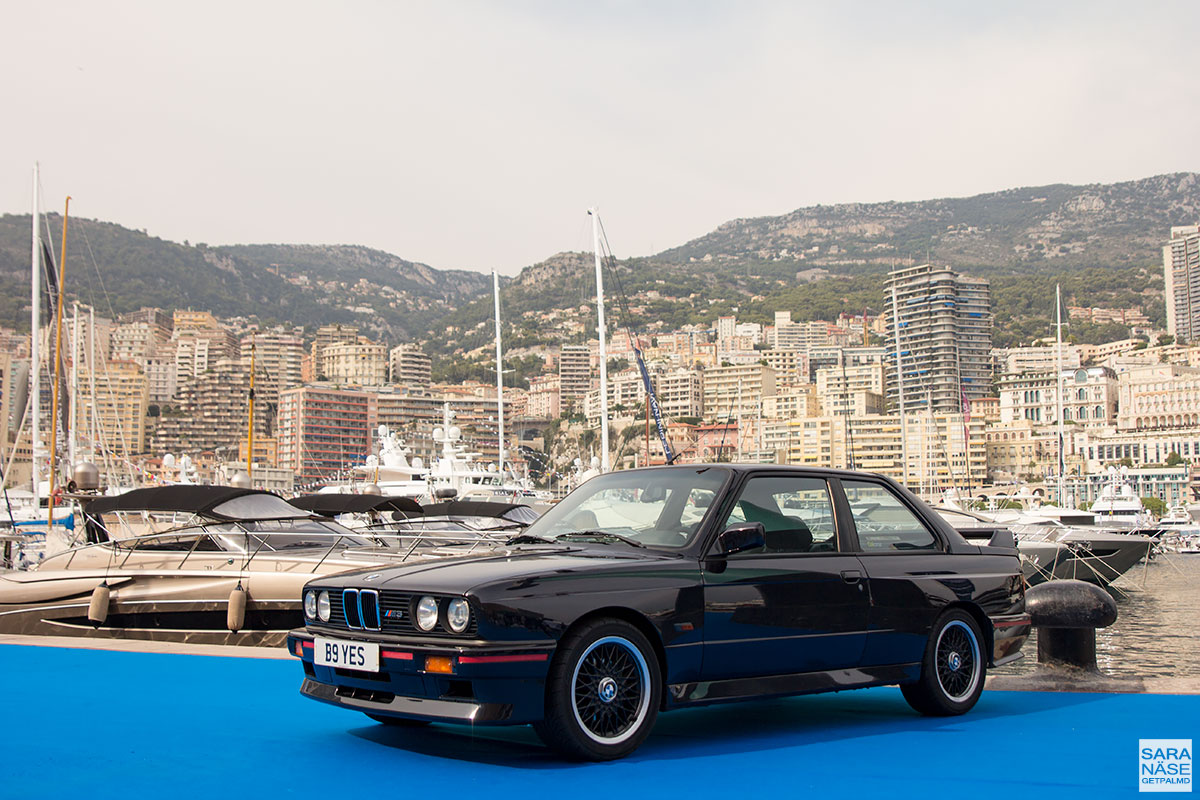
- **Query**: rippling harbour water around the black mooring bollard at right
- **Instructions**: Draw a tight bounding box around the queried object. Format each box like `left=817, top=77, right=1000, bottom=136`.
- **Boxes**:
left=995, top=554, right=1200, bottom=678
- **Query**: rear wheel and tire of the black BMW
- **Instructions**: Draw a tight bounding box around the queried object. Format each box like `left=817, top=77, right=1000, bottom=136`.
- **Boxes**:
left=900, top=608, right=988, bottom=716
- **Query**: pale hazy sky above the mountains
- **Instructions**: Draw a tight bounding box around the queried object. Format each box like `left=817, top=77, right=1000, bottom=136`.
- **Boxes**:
left=0, top=0, right=1200, bottom=275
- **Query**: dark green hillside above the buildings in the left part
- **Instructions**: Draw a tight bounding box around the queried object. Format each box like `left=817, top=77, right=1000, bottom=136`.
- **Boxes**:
left=0, top=215, right=490, bottom=342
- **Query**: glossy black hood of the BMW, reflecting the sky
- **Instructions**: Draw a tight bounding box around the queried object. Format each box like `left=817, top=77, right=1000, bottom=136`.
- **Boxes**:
left=313, top=545, right=679, bottom=594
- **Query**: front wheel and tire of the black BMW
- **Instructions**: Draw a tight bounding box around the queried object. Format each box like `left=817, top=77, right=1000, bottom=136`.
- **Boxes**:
left=533, top=619, right=662, bottom=762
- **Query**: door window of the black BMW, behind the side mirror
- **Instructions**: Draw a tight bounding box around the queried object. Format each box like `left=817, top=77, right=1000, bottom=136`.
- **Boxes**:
left=725, top=476, right=838, bottom=558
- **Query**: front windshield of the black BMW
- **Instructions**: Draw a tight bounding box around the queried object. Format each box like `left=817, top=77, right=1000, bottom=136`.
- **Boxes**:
left=524, top=467, right=730, bottom=548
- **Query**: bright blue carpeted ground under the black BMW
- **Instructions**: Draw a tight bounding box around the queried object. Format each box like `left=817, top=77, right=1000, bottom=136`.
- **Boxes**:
left=0, top=645, right=1200, bottom=800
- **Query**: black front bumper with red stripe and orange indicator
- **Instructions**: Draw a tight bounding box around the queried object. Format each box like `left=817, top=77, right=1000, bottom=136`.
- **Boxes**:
left=288, top=630, right=553, bottom=724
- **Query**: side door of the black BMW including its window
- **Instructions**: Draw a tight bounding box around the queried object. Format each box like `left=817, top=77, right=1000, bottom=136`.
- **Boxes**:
left=702, top=473, right=869, bottom=680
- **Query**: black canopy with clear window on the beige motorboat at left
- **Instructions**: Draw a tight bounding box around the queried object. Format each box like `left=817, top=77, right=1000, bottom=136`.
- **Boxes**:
left=85, top=485, right=312, bottom=519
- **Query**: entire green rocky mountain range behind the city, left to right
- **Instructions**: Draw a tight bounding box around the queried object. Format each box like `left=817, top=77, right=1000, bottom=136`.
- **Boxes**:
left=0, top=173, right=1180, bottom=357
